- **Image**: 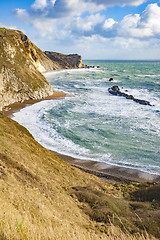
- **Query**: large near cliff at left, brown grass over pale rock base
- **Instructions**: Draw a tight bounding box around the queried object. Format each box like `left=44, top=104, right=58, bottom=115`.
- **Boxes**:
left=0, top=28, right=55, bottom=110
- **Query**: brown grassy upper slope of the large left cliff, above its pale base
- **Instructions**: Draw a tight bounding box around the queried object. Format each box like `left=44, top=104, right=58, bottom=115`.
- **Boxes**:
left=0, top=28, right=51, bottom=89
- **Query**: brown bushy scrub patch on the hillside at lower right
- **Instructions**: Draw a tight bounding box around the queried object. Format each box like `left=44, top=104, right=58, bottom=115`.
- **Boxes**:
left=71, top=184, right=160, bottom=238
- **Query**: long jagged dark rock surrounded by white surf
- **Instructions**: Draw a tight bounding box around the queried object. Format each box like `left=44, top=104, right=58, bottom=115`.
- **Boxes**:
left=108, top=86, right=152, bottom=106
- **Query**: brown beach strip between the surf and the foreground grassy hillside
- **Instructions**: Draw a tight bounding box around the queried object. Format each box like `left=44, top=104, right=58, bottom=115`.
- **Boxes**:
left=53, top=151, right=160, bottom=183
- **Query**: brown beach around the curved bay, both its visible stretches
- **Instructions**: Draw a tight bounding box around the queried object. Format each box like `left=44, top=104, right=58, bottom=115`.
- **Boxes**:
left=2, top=92, right=160, bottom=183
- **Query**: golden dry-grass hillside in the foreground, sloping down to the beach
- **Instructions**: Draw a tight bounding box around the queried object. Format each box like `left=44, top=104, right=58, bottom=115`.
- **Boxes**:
left=0, top=113, right=160, bottom=240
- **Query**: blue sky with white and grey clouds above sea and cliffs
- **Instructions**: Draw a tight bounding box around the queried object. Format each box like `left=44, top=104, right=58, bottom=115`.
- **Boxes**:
left=0, top=0, right=160, bottom=60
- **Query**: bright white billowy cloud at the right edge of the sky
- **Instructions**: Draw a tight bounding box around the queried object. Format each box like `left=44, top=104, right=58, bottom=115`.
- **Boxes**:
left=100, top=4, right=160, bottom=38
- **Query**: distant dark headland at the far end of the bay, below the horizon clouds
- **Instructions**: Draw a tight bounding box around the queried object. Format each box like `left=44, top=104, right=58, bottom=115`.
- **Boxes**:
left=45, top=51, right=85, bottom=69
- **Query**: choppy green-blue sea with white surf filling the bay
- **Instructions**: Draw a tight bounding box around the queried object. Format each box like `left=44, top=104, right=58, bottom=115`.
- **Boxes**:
left=13, top=60, right=160, bottom=175
